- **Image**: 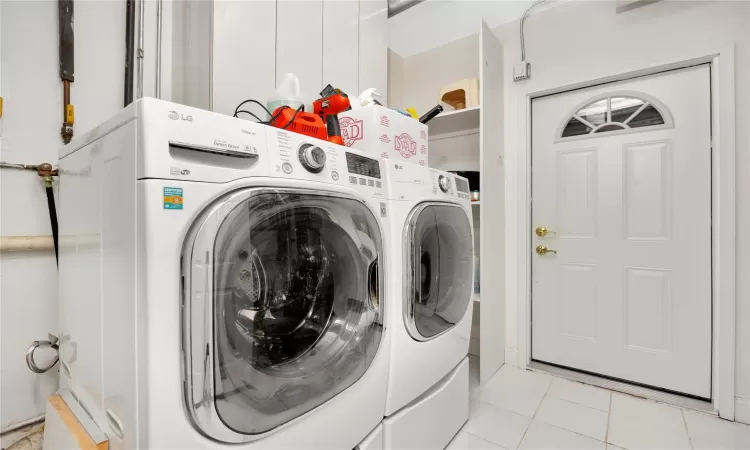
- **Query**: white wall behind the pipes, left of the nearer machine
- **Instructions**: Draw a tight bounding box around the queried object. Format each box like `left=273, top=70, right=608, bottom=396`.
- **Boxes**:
left=0, top=0, right=125, bottom=428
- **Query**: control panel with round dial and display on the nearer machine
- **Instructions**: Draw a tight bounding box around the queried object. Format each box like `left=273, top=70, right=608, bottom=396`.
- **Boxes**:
left=266, top=127, right=386, bottom=197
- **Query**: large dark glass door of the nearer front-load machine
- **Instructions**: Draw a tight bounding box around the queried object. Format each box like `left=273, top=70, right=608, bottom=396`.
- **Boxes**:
left=188, top=190, right=383, bottom=434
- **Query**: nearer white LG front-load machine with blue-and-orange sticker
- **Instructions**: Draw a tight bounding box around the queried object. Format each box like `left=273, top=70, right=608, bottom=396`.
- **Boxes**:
left=53, top=99, right=390, bottom=450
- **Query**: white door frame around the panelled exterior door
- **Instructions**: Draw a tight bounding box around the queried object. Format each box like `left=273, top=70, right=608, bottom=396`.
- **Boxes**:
left=509, top=45, right=736, bottom=420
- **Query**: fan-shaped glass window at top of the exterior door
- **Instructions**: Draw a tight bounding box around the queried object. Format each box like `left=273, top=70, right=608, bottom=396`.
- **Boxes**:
left=560, top=95, right=668, bottom=138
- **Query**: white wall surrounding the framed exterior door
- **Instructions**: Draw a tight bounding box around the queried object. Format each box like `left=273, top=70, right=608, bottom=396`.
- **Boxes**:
left=494, top=1, right=750, bottom=420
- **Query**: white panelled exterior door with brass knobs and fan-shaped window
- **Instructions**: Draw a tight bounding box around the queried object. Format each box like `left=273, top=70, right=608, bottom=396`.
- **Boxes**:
left=530, top=65, right=711, bottom=399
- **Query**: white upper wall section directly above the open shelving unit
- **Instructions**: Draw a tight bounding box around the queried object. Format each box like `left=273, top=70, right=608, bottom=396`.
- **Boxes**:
left=388, top=0, right=543, bottom=58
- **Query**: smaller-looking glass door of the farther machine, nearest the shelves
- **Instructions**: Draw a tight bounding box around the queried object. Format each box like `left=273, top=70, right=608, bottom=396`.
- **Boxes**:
left=406, top=203, right=473, bottom=340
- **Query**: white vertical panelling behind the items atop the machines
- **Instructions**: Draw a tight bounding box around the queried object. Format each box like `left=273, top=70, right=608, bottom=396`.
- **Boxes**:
left=173, top=0, right=388, bottom=114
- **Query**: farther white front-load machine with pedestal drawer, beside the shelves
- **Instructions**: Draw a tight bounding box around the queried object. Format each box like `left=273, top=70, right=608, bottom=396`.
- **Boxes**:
left=383, top=160, right=474, bottom=449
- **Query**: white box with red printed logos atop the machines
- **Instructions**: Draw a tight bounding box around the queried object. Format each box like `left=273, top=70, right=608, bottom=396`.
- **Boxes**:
left=339, top=105, right=428, bottom=166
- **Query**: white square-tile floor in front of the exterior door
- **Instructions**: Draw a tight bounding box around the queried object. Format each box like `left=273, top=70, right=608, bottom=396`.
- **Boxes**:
left=447, top=358, right=750, bottom=450
